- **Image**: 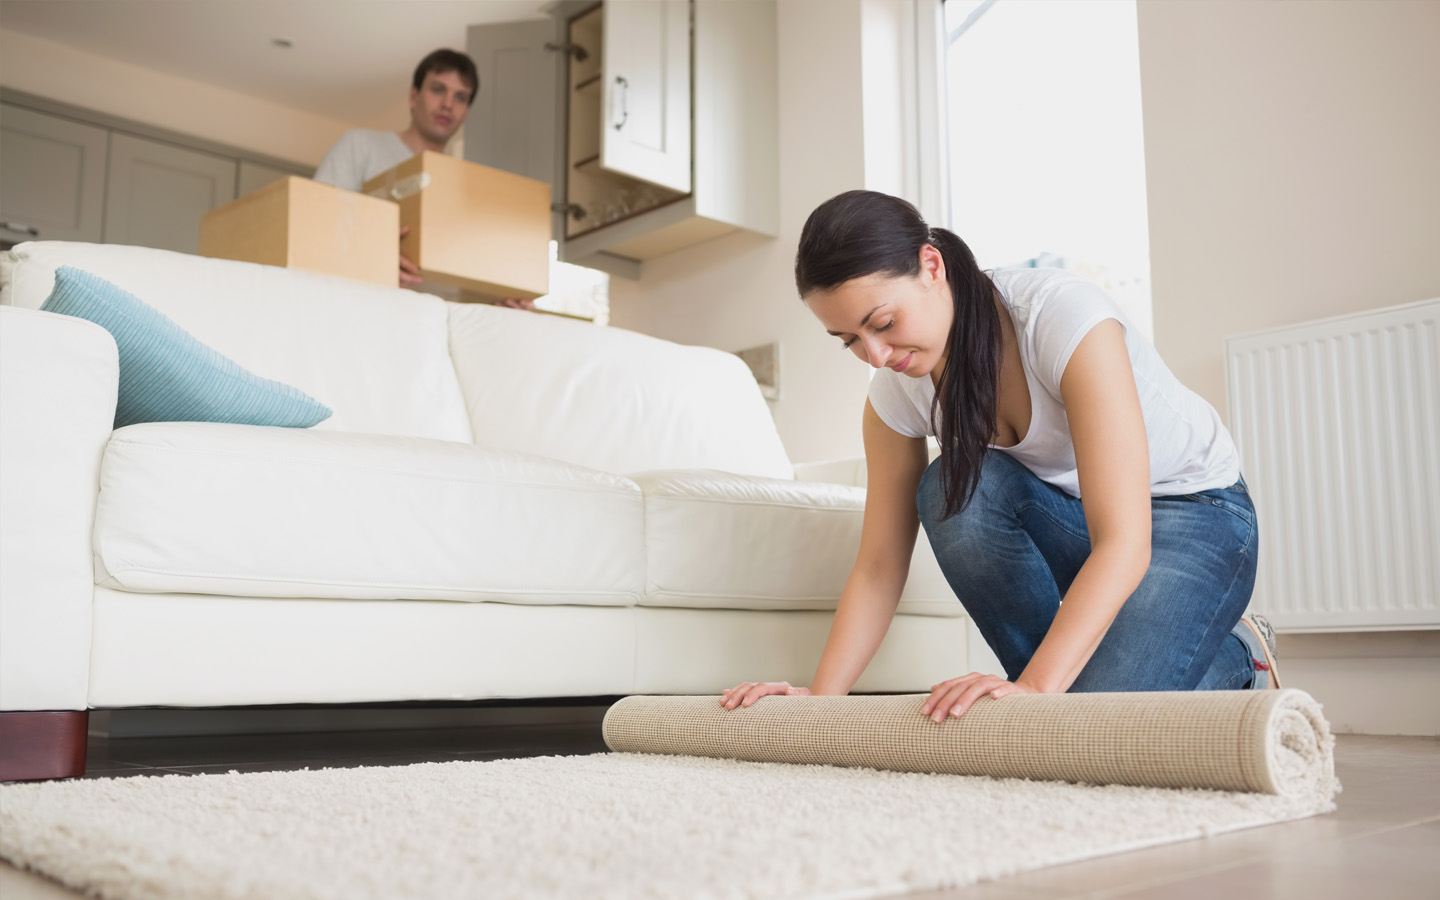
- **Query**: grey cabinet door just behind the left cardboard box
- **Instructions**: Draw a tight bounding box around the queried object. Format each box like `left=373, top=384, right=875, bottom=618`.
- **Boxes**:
left=105, top=132, right=236, bottom=253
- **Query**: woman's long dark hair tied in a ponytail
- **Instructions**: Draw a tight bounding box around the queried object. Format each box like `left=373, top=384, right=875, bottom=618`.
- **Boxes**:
left=795, top=190, right=1001, bottom=518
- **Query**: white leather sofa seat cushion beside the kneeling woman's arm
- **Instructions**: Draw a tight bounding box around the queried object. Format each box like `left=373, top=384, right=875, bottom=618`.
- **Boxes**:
left=632, top=469, right=965, bottom=616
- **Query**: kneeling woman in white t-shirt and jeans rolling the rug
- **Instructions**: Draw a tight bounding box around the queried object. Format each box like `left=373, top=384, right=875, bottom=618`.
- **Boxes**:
left=721, top=190, right=1274, bottom=721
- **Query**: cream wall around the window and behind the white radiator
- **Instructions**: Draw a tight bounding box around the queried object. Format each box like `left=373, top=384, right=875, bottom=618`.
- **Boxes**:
left=622, top=0, right=1440, bottom=734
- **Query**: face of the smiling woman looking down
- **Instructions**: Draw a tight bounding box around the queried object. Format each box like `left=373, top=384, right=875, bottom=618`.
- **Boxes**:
left=805, top=245, right=955, bottom=379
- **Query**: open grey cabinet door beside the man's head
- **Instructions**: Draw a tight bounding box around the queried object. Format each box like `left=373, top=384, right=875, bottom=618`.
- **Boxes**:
left=465, top=19, right=563, bottom=184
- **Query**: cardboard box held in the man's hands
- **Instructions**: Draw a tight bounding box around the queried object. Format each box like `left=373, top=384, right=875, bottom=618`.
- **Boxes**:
left=364, top=151, right=550, bottom=301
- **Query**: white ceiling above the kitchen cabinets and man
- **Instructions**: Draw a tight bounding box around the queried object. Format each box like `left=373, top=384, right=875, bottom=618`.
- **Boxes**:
left=0, top=0, right=546, bottom=124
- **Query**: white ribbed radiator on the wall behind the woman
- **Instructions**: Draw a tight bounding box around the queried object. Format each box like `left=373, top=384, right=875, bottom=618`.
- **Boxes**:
left=1225, top=300, right=1440, bottom=631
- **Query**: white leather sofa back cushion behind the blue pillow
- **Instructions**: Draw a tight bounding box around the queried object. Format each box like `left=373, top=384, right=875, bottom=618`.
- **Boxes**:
left=0, top=240, right=471, bottom=441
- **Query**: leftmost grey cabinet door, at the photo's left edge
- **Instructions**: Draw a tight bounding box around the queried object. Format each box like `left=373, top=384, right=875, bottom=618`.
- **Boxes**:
left=0, top=104, right=109, bottom=243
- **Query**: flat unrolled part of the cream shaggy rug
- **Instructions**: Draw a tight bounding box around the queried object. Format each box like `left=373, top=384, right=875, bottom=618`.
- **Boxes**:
left=0, top=698, right=1335, bottom=900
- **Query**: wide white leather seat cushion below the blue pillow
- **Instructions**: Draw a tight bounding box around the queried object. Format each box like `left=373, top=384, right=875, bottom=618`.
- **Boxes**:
left=95, top=422, right=645, bottom=605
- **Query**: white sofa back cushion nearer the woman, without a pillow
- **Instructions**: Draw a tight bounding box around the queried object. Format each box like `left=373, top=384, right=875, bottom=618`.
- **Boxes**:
left=451, top=304, right=793, bottom=478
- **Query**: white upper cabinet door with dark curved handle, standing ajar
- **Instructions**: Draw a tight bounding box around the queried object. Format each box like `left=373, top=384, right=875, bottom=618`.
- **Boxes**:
left=600, top=0, right=690, bottom=193
